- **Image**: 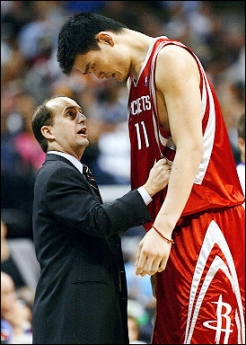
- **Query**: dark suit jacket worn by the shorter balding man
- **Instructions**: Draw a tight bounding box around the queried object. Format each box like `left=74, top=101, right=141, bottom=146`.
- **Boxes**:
left=33, top=154, right=150, bottom=344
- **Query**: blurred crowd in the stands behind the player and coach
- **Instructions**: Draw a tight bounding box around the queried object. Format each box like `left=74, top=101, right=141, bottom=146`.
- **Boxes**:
left=1, top=1, right=245, bottom=344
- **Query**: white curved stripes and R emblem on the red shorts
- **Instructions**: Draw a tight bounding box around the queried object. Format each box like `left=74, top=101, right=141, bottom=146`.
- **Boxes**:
left=184, top=221, right=245, bottom=344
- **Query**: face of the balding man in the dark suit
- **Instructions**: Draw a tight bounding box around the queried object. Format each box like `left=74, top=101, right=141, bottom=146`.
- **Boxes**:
left=42, top=97, right=89, bottom=160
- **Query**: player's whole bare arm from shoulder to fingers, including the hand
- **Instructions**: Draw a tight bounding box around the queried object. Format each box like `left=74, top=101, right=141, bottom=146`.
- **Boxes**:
left=136, top=46, right=203, bottom=275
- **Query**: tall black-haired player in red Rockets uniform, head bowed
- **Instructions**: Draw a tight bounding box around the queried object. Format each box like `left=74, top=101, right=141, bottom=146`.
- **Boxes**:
left=57, top=13, right=245, bottom=344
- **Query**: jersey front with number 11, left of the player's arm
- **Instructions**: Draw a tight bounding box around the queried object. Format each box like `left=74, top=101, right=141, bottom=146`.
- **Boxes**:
left=128, top=37, right=169, bottom=188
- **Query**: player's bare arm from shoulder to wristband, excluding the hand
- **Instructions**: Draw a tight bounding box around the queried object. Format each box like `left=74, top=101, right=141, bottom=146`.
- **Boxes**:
left=155, top=46, right=203, bottom=227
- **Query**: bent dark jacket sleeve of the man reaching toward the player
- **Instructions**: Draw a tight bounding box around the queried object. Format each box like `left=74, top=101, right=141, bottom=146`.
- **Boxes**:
left=34, top=161, right=151, bottom=237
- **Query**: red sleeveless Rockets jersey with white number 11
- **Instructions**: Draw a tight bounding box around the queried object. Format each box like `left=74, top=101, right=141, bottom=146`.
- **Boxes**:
left=128, top=36, right=244, bottom=229
